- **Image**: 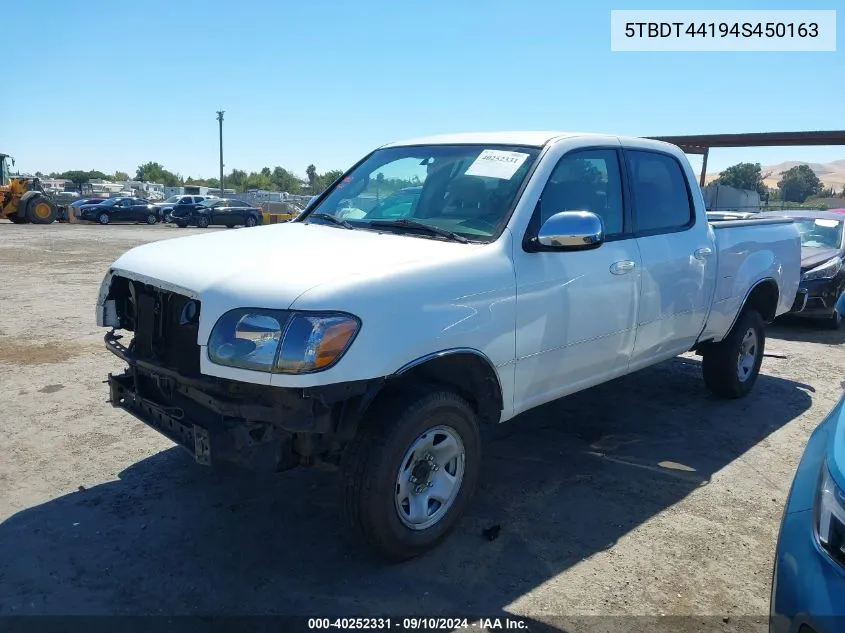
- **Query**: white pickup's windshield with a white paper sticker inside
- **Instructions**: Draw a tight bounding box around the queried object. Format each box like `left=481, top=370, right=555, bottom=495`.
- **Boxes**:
left=300, top=145, right=540, bottom=241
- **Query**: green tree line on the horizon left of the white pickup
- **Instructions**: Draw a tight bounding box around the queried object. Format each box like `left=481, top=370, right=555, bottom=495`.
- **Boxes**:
left=42, top=161, right=343, bottom=194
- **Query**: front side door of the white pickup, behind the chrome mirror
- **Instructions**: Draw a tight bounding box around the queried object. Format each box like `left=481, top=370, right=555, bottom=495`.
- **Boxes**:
left=514, top=147, right=640, bottom=412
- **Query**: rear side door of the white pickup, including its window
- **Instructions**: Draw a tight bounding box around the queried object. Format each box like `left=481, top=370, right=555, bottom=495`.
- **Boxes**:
left=623, top=149, right=716, bottom=371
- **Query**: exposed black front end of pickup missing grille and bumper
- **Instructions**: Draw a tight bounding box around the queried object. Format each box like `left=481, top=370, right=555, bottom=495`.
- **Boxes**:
left=98, top=272, right=381, bottom=471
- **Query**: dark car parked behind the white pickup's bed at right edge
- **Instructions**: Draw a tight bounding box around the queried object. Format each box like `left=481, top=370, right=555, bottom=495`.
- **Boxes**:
left=756, top=211, right=845, bottom=329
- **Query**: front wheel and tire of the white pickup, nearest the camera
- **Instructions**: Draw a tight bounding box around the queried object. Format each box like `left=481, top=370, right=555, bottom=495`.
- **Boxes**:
left=341, top=390, right=481, bottom=562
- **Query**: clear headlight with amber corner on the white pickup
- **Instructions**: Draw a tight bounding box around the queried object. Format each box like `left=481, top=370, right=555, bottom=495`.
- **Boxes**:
left=208, top=308, right=361, bottom=374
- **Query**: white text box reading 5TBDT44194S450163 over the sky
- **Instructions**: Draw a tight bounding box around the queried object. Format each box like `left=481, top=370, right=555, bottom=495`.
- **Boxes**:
left=610, top=9, right=836, bottom=52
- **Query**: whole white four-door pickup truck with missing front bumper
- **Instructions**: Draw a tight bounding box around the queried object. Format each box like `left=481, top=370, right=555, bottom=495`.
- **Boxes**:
left=97, top=132, right=801, bottom=560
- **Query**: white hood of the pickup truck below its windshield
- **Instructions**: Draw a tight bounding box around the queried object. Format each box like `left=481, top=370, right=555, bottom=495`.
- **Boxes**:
left=111, top=223, right=478, bottom=312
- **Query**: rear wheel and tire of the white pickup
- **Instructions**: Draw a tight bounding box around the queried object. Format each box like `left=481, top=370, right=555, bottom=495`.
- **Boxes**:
left=701, top=308, right=766, bottom=398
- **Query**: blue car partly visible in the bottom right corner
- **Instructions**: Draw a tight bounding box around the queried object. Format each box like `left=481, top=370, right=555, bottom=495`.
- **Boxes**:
left=769, top=293, right=845, bottom=633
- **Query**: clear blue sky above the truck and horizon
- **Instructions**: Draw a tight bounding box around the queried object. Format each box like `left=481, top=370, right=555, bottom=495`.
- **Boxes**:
left=0, top=0, right=845, bottom=177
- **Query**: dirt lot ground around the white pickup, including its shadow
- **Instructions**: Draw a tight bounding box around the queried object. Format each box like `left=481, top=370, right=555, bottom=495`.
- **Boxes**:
left=0, top=222, right=845, bottom=630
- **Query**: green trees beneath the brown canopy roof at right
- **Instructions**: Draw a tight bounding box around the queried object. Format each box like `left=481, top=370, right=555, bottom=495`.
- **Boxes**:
left=713, top=163, right=845, bottom=203
